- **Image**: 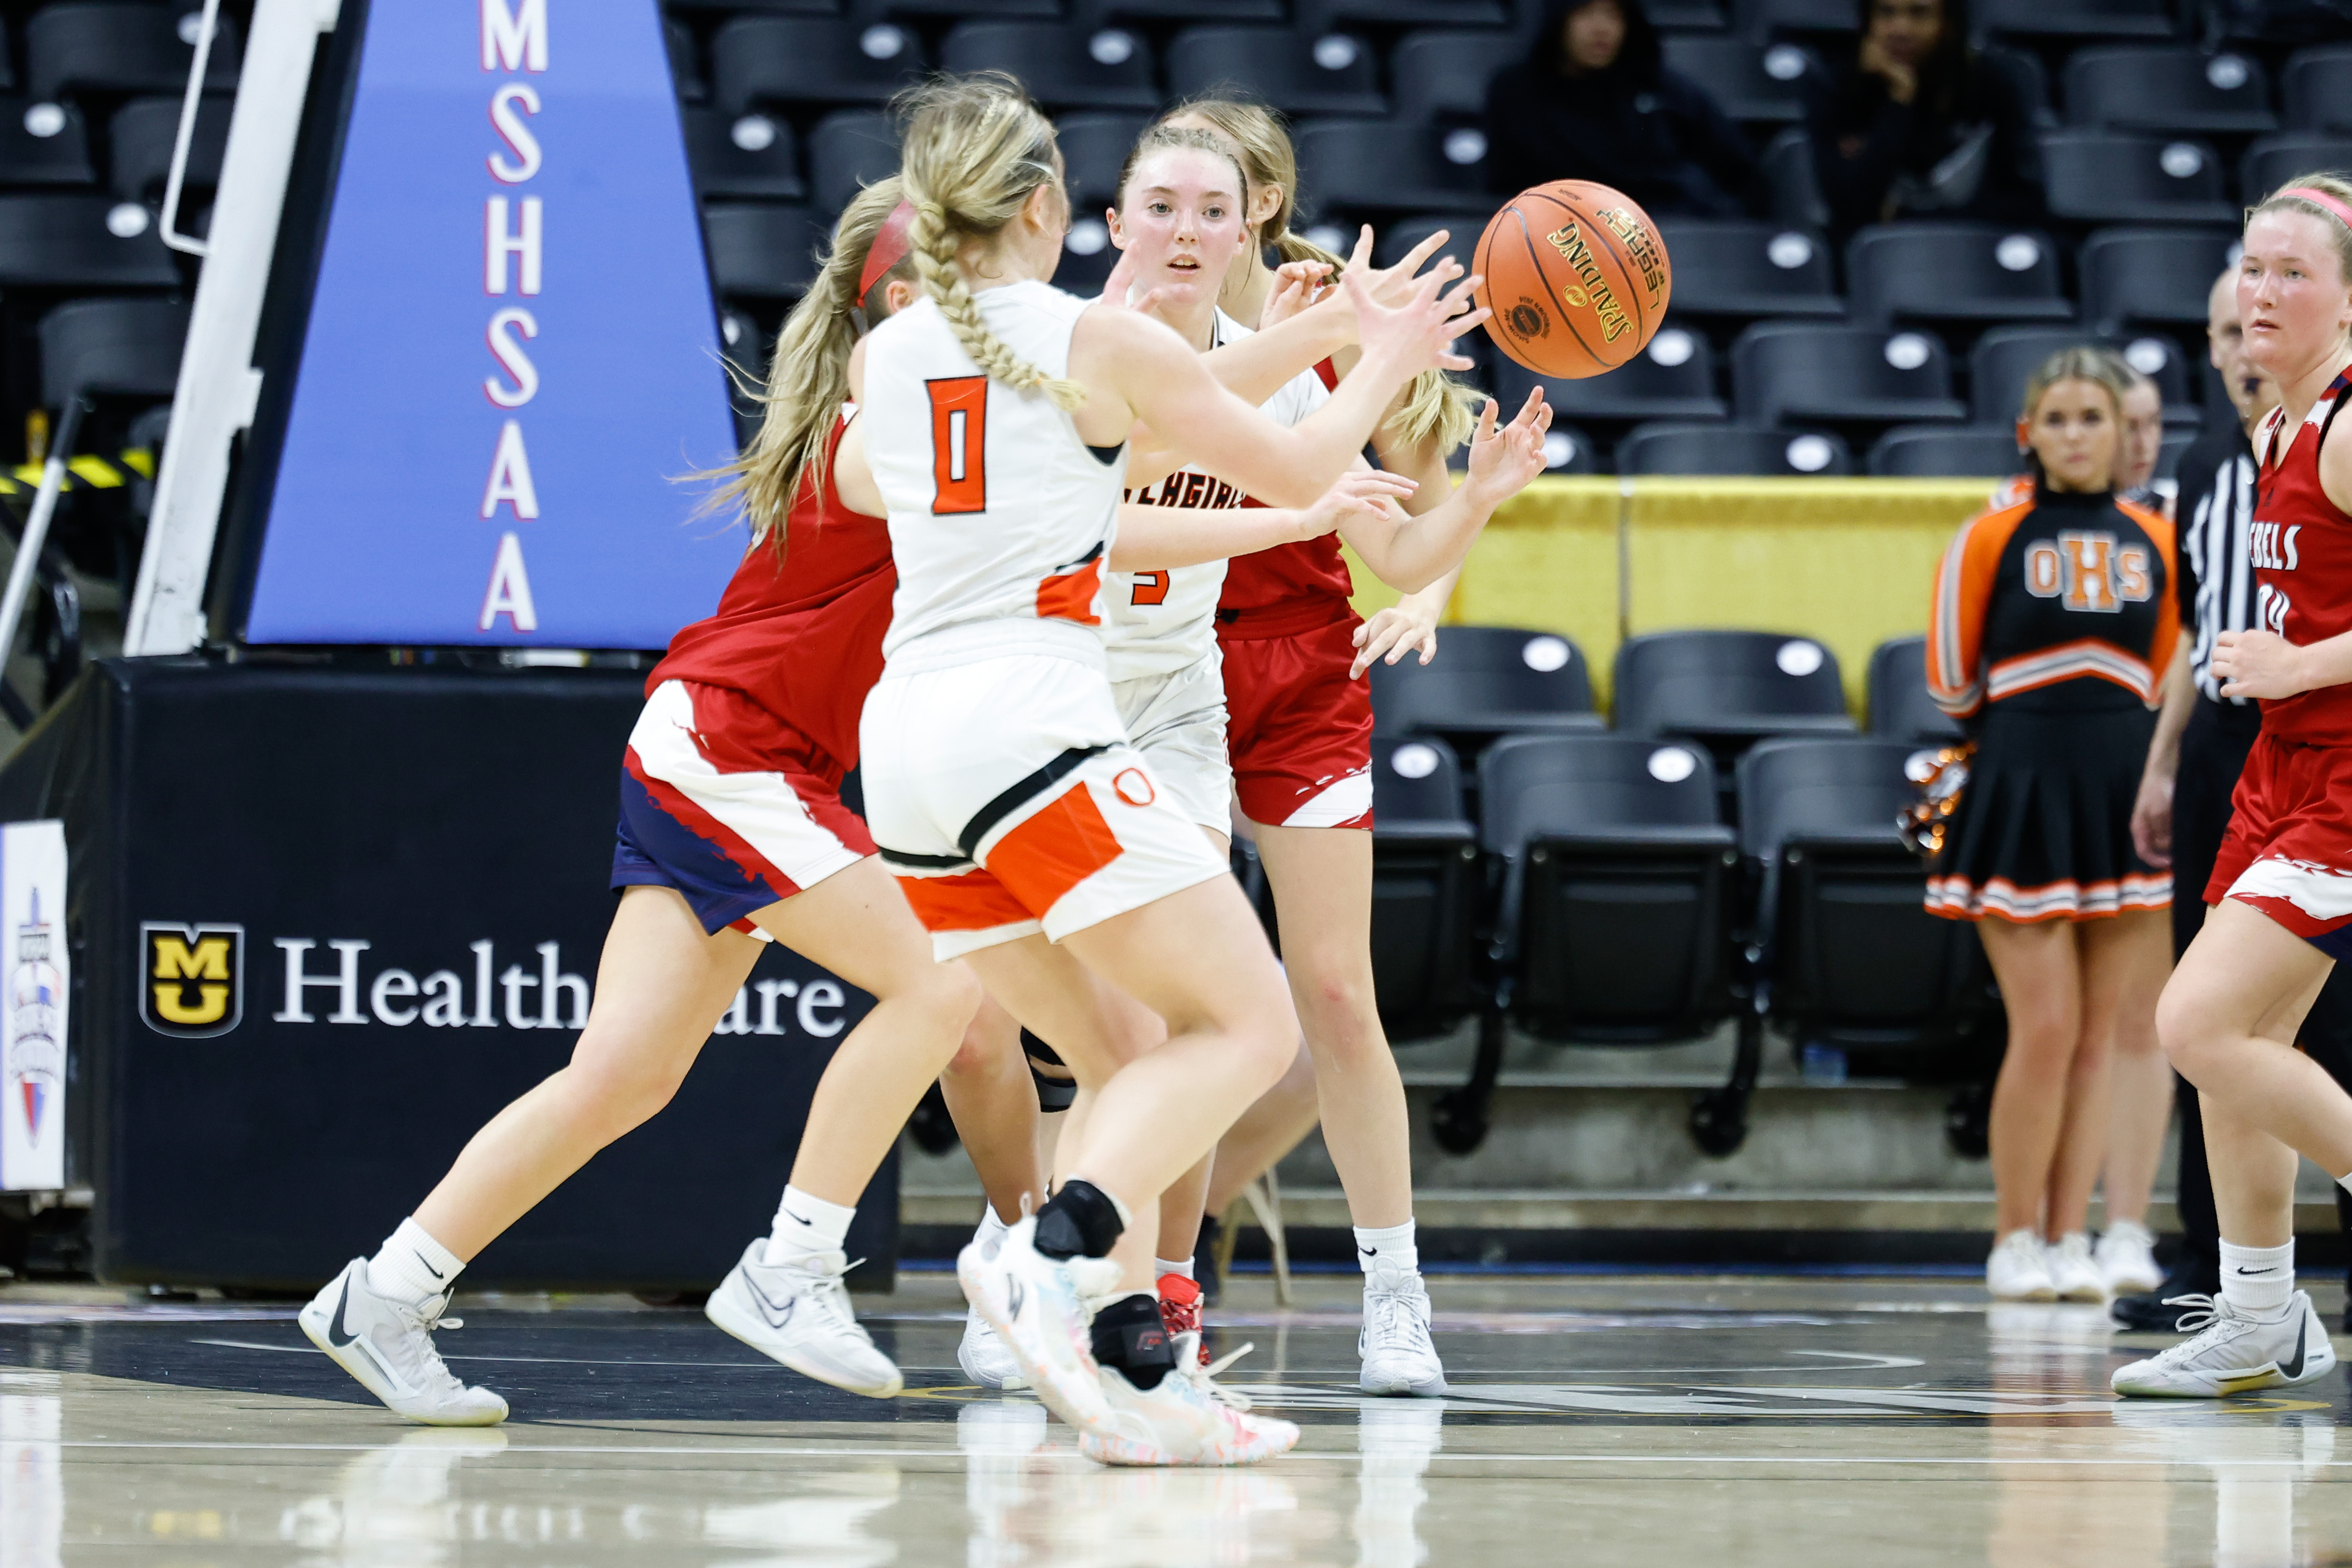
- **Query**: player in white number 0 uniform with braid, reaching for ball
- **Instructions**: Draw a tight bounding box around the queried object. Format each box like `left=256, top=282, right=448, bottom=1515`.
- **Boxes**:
left=861, top=75, right=1484, bottom=1465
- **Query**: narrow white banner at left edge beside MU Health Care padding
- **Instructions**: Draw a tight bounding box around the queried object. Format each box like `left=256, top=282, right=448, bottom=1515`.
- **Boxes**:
left=0, top=823, right=71, bottom=1192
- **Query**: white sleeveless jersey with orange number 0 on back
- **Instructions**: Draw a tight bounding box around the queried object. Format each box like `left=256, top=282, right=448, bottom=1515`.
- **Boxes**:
left=863, top=282, right=1127, bottom=656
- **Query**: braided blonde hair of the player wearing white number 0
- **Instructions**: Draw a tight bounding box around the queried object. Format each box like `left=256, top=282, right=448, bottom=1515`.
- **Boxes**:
left=894, top=71, right=1087, bottom=409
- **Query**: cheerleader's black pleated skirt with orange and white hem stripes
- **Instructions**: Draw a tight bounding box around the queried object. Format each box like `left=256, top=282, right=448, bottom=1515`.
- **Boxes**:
left=1926, top=707, right=2173, bottom=922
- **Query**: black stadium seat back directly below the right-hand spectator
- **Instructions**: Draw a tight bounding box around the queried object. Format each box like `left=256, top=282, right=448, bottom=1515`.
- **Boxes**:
left=1846, top=221, right=2074, bottom=327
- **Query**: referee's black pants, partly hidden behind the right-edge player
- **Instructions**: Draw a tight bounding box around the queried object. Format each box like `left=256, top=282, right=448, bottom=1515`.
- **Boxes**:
left=2173, top=698, right=2352, bottom=1269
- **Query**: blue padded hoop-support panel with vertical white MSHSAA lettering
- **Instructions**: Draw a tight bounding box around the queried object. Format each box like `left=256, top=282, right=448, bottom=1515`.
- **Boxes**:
left=244, top=0, right=741, bottom=649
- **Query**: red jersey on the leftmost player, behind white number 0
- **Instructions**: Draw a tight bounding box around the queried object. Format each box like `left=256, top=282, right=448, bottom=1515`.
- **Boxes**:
left=644, top=418, right=898, bottom=773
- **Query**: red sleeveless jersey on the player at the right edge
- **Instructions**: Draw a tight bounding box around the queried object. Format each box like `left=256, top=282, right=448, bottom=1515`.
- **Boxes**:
left=2251, top=371, right=2352, bottom=745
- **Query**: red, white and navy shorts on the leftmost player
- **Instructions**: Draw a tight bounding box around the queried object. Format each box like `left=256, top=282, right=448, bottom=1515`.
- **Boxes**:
left=611, top=680, right=875, bottom=931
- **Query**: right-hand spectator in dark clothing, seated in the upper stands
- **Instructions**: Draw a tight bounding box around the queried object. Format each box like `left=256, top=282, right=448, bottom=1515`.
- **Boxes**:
left=1804, top=0, right=2044, bottom=240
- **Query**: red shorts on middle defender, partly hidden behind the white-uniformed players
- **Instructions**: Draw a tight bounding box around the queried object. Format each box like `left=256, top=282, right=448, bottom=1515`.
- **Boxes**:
left=1216, top=604, right=1371, bottom=830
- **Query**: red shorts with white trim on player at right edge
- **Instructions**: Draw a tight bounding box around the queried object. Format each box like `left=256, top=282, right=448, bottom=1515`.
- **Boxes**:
left=2206, top=731, right=2352, bottom=959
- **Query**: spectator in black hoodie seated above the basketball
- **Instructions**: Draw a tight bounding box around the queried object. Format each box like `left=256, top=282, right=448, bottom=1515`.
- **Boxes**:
left=1487, top=0, right=1757, bottom=219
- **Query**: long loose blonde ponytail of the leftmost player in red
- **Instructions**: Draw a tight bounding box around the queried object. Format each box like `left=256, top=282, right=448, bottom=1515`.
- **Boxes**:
left=703, top=174, right=912, bottom=555
